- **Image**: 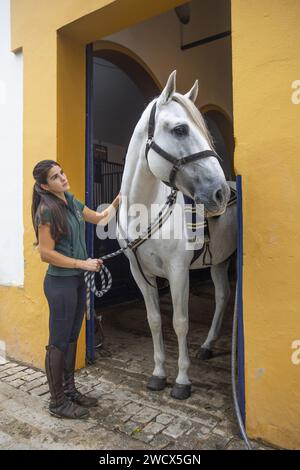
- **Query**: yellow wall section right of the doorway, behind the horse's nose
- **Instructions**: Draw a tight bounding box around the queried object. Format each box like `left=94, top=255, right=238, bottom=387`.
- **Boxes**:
left=232, top=0, right=300, bottom=448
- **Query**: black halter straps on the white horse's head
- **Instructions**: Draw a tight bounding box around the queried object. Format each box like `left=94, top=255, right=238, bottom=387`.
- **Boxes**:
left=145, top=101, right=220, bottom=189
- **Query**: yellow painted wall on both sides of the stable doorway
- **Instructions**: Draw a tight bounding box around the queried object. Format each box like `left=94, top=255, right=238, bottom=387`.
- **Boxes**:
left=0, top=0, right=300, bottom=447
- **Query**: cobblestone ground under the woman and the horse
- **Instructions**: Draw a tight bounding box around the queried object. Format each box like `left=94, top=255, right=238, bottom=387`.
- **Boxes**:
left=0, top=282, right=274, bottom=450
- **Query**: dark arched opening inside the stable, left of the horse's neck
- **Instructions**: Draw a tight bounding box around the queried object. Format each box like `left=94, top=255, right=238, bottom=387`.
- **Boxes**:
left=92, top=41, right=160, bottom=307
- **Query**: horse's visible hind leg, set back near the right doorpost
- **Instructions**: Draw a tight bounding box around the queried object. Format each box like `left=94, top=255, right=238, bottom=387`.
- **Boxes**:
left=196, top=260, right=230, bottom=359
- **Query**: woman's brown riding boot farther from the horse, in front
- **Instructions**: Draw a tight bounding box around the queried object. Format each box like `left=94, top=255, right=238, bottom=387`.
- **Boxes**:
left=45, top=345, right=89, bottom=419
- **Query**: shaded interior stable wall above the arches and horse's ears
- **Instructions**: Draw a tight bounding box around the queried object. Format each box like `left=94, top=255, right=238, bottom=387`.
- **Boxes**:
left=104, top=0, right=232, bottom=116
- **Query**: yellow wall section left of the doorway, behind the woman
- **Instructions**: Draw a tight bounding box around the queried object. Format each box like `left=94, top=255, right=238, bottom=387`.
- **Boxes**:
left=0, top=0, right=180, bottom=367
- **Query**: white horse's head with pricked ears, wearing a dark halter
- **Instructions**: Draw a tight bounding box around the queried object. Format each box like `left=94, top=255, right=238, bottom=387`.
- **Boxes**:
left=146, top=71, right=230, bottom=214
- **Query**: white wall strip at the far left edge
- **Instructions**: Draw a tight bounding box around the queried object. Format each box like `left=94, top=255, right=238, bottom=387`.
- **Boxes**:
left=0, top=0, right=24, bottom=286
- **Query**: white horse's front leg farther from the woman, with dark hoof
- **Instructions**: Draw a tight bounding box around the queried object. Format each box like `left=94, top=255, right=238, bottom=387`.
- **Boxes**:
left=169, top=267, right=191, bottom=400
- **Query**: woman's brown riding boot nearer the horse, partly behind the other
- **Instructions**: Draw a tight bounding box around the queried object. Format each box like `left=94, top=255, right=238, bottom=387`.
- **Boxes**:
left=64, top=341, right=98, bottom=408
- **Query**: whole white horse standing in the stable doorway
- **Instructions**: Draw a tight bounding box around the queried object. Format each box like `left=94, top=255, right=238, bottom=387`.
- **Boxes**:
left=117, top=71, right=236, bottom=399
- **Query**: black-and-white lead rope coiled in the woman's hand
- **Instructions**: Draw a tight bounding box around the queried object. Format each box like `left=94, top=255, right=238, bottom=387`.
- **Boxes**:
left=84, top=189, right=177, bottom=308
